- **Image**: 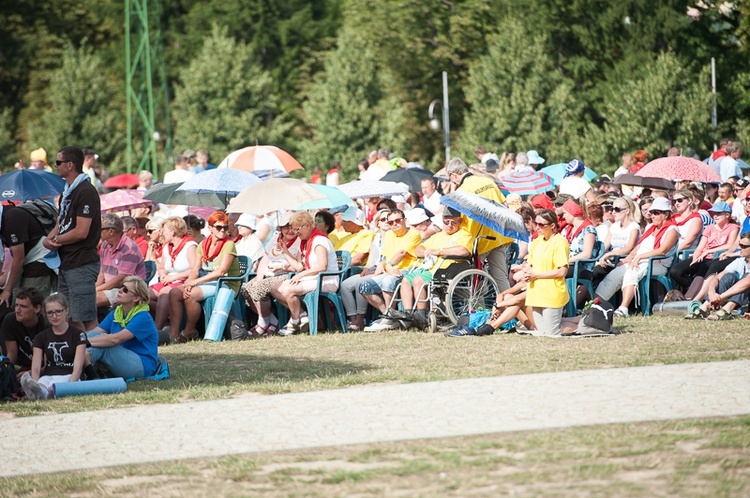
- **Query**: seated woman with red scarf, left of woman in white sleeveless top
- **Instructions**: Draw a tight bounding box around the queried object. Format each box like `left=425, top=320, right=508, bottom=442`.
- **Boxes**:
left=242, top=214, right=301, bottom=337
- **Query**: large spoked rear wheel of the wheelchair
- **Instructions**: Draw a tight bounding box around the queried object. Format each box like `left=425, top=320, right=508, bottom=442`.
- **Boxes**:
left=445, top=269, right=499, bottom=324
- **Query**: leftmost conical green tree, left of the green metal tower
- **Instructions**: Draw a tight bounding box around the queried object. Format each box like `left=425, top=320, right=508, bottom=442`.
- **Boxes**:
left=29, top=44, right=125, bottom=165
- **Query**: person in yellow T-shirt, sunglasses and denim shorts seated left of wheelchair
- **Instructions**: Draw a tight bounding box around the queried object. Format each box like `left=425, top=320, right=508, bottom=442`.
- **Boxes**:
left=359, top=209, right=422, bottom=332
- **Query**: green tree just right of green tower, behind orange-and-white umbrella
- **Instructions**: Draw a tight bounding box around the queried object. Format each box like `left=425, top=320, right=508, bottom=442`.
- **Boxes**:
left=173, top=25, right=289, bottom=165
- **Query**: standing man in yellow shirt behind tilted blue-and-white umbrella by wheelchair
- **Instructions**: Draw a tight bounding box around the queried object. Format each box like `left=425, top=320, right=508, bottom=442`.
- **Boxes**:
left=445, top=158, right=513, bottom=292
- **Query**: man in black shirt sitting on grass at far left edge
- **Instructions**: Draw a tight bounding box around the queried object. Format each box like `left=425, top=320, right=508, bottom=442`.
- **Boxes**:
left=0, top=288, right=47, bottom=371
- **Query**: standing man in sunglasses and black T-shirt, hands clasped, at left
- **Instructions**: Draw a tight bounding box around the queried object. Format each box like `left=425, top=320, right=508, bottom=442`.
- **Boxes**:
left=43, top=146, right=102, bottom=330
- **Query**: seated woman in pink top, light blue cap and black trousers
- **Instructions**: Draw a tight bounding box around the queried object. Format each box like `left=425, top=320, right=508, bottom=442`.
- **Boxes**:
left=669, top=202, right=740, bottom=294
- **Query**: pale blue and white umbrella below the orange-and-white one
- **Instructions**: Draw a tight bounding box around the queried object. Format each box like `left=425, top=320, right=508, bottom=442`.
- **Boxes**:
left=176, top=168, right=261, bottom=208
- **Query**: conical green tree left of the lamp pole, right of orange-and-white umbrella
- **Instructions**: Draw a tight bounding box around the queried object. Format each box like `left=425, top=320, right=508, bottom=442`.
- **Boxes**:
left=301, top=28, right=406, bottom=177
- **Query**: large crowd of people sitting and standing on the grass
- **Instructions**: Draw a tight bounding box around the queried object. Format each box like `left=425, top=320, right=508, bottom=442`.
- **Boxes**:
left=0, top=140, right=750, bottom=399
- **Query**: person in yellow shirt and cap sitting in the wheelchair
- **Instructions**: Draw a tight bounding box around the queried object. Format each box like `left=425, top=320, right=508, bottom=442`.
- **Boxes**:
left=391, top=207, right=473, bottom=328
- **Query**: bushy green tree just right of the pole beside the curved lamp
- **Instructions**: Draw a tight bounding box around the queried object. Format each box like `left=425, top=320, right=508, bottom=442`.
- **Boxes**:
left=459, top=18, right=581, bottom=162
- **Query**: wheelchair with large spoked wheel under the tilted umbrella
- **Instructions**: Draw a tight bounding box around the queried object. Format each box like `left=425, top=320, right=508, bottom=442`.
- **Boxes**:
left=388, top=237, right=499, bottom=333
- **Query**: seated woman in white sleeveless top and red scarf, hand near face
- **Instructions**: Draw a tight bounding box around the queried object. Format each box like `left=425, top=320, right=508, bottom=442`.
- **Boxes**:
left=271, top=212, right=339, bottom=336
